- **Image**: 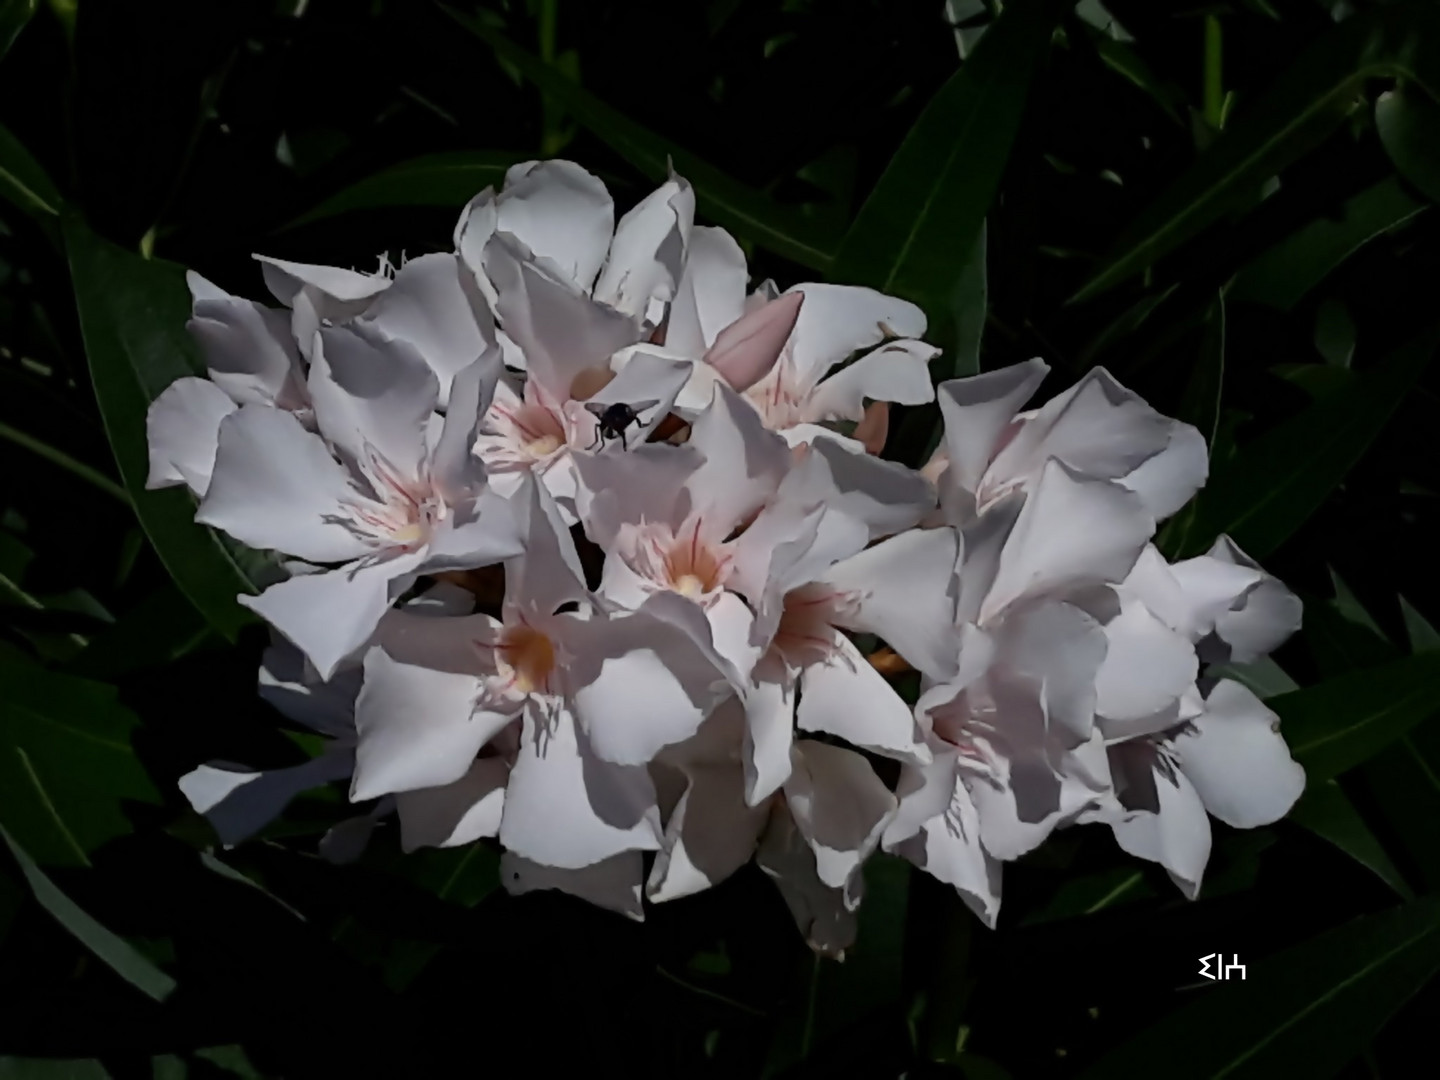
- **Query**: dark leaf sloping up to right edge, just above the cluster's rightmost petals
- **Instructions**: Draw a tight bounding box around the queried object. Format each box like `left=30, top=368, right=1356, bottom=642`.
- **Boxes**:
left=1179, top=325, right=1440, bottom=559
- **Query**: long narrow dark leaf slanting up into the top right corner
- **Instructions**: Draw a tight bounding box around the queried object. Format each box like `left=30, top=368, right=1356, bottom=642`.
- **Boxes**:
left=1070, top=4, right=1440, bottom=302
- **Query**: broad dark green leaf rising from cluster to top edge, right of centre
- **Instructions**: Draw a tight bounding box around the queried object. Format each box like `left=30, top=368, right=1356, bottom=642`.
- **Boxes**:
left=829, top=0, right=1064, bottom=317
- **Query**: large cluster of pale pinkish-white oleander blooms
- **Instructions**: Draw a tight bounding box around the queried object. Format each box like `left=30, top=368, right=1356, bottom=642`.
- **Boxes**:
left=148, top=161, right=1305, bottom=955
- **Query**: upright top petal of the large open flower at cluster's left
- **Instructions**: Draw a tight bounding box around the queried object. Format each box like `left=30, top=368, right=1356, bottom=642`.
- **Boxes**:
left=310, top=327, right=439, bottom=480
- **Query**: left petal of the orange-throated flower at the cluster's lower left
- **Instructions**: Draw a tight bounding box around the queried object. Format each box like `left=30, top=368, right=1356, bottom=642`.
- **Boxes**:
left=350, top=648, right=511, bottom=802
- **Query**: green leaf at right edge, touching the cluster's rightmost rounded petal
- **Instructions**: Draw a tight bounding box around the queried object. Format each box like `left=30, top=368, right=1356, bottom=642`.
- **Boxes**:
left=1267, top=652, right=1440, bottom=785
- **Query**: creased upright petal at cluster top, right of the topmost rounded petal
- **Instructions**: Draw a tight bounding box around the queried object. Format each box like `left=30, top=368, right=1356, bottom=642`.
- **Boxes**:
left=595, top=176, right=696, bottom=318
